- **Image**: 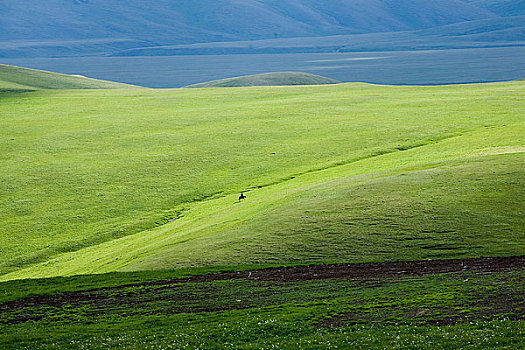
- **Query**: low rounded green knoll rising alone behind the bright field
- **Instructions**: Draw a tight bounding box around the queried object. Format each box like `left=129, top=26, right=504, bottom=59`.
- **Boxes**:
left=187, top=72, right=339, bottom=88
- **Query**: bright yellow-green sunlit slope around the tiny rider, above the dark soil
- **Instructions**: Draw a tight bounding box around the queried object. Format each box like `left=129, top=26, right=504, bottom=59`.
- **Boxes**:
left=0, top=82, right=525, bottom=279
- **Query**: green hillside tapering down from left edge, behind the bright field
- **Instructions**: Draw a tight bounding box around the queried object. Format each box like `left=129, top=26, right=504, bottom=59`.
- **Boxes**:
left=0, top=64, right=133, bottom=92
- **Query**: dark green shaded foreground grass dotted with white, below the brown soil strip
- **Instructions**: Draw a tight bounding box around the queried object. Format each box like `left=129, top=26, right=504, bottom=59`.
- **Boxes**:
left=0, top=270, right=525, bottom=349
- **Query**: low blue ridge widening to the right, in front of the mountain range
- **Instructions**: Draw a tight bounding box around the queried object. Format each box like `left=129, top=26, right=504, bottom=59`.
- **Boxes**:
left=109, top=16, right=525, bottom=56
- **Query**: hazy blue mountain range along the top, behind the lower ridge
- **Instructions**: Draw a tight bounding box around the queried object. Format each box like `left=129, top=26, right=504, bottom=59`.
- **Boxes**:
left=0, top=0, right=525, bottom=57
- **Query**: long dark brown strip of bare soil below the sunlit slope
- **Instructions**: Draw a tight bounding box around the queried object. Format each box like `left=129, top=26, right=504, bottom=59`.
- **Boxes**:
left=0, top=256, right=525, bottom=313
